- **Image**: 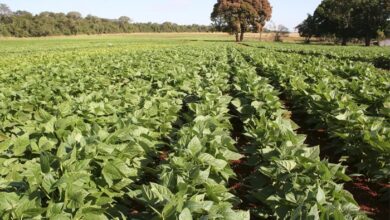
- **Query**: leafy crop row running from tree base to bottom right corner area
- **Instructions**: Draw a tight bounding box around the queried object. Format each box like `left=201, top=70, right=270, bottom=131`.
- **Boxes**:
left=230, top=51, right=366, bottom=219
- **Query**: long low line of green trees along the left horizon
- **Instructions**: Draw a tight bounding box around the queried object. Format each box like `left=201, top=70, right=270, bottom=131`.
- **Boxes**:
left=0, top=4, right=211, bottom=37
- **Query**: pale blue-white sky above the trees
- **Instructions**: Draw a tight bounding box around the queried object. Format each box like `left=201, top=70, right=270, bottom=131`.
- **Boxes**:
left=0, top=0, right=321, bottom=30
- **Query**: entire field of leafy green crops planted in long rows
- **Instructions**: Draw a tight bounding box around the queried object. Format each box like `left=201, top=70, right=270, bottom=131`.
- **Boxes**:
left=0, top=36, right=390, bottom=220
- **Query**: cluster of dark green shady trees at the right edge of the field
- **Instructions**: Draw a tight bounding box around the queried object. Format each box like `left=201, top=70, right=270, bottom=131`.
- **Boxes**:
left=297, top=0, right=390, bottom=46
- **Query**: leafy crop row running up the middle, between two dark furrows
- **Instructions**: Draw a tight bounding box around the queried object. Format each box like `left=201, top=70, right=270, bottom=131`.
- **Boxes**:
left=129, top=50, right=250, bottom=220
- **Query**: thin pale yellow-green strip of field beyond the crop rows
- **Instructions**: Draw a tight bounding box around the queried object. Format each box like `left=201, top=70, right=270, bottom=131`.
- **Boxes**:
left=0, top=33, right=388, bottom=53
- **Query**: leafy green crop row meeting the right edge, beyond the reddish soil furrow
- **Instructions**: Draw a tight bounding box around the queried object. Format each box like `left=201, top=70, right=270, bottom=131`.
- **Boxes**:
left=239, top=47, right=390, bottom=184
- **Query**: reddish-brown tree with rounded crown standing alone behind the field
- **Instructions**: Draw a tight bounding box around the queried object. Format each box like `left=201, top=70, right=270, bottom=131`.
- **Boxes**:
left=211, top=0, right=272, bottom=42
